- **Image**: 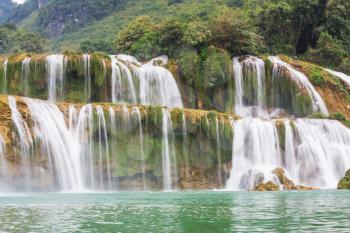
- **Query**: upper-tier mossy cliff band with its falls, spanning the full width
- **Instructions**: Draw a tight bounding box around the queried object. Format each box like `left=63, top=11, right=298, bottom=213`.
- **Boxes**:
left=0, top=52, right=350, bottom=118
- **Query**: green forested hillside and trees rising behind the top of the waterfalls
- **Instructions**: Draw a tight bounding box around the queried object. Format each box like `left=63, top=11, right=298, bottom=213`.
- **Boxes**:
left=0, top=0, right=350, bottom=73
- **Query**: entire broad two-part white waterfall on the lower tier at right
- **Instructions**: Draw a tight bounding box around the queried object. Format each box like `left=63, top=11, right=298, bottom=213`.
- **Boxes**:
left=226, top=118, right=350, bottom=190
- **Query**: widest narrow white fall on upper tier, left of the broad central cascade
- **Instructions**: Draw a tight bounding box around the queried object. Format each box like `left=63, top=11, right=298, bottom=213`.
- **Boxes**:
left=46, top=54, right=64, bottom=102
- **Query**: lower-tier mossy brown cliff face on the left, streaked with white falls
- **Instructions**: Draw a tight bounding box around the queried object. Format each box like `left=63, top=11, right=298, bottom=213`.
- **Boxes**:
left=0, top=96, right=236, bottom=190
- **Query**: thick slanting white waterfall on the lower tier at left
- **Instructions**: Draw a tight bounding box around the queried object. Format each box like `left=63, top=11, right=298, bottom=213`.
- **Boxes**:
left=25, top=98, right=84, bottom=191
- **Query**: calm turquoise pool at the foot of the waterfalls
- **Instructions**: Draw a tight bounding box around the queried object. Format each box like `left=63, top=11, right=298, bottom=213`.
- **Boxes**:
left=0, top=191, right=350, bottom=233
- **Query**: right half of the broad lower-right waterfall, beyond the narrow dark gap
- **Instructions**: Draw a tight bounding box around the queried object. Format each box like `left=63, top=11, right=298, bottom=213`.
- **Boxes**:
left=287, top=119, right=350, bottom=188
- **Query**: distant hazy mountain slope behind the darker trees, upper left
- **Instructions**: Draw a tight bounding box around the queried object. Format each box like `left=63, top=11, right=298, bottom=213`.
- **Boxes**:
left=9, top=0, right=242, bottom=50
